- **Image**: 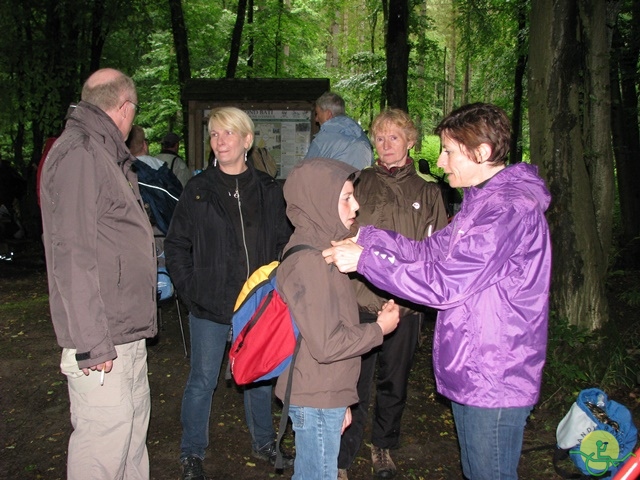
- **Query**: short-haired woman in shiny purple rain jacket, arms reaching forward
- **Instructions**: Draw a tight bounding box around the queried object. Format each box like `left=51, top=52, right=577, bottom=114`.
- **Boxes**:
left=324, top=103, right=551, bottom=480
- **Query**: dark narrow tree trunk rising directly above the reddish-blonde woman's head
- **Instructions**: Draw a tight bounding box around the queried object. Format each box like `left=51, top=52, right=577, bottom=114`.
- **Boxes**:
left=386, top=0, right=409, bottom=111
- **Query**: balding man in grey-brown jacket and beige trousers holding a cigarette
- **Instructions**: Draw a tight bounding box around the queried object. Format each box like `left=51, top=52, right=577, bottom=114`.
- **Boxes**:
left=40, top=69, right=157, bottom=480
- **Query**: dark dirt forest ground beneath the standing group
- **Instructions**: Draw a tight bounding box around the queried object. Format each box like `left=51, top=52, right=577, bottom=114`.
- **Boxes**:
left=0, top=242, right=636, bottom=480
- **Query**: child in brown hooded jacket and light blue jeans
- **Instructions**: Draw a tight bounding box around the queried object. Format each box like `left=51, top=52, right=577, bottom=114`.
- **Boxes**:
left=276, top=158, right=399, bottom=480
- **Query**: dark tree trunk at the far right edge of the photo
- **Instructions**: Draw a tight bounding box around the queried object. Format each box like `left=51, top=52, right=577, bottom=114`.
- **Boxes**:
left=611, top=2, right=640, bottom=258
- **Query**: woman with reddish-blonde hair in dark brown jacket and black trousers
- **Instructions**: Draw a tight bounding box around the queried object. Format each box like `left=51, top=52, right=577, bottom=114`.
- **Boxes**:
left=338, top=108, right=447, bottom=480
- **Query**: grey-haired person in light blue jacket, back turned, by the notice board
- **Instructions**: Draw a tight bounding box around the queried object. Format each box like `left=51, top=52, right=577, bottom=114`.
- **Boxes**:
left=305, top=92, right=373, bottom=170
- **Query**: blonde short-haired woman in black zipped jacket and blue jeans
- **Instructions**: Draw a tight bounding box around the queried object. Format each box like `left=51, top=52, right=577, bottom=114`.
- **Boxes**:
left=164, top=107, right=293, bottom=480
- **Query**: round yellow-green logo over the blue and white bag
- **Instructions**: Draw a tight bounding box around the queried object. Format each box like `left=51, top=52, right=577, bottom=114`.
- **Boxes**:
left=569, top=430, right=633, bottom=477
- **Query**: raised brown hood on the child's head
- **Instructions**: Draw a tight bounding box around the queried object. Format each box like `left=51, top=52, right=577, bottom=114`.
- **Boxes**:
left=284, top=158, right=359, bottom=250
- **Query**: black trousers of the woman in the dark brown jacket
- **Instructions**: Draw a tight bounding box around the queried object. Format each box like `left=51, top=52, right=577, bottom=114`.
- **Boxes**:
left=338, top=312, right=420, bottom=469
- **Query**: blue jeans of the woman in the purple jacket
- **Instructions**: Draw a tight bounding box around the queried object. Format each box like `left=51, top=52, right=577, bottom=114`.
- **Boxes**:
left=451, top=402, right=533, bottom=480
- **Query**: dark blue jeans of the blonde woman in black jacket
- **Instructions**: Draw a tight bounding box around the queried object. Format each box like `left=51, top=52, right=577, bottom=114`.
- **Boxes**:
left=180, top=314, right=275, bottom=459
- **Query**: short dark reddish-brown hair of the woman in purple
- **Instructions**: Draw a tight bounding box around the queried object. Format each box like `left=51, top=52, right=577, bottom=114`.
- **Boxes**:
left=435, top=103, right=511, bottom=164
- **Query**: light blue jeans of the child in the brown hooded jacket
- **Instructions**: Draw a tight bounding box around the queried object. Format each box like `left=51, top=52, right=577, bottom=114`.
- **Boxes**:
left=289, top=405, right=347, bottom=480
